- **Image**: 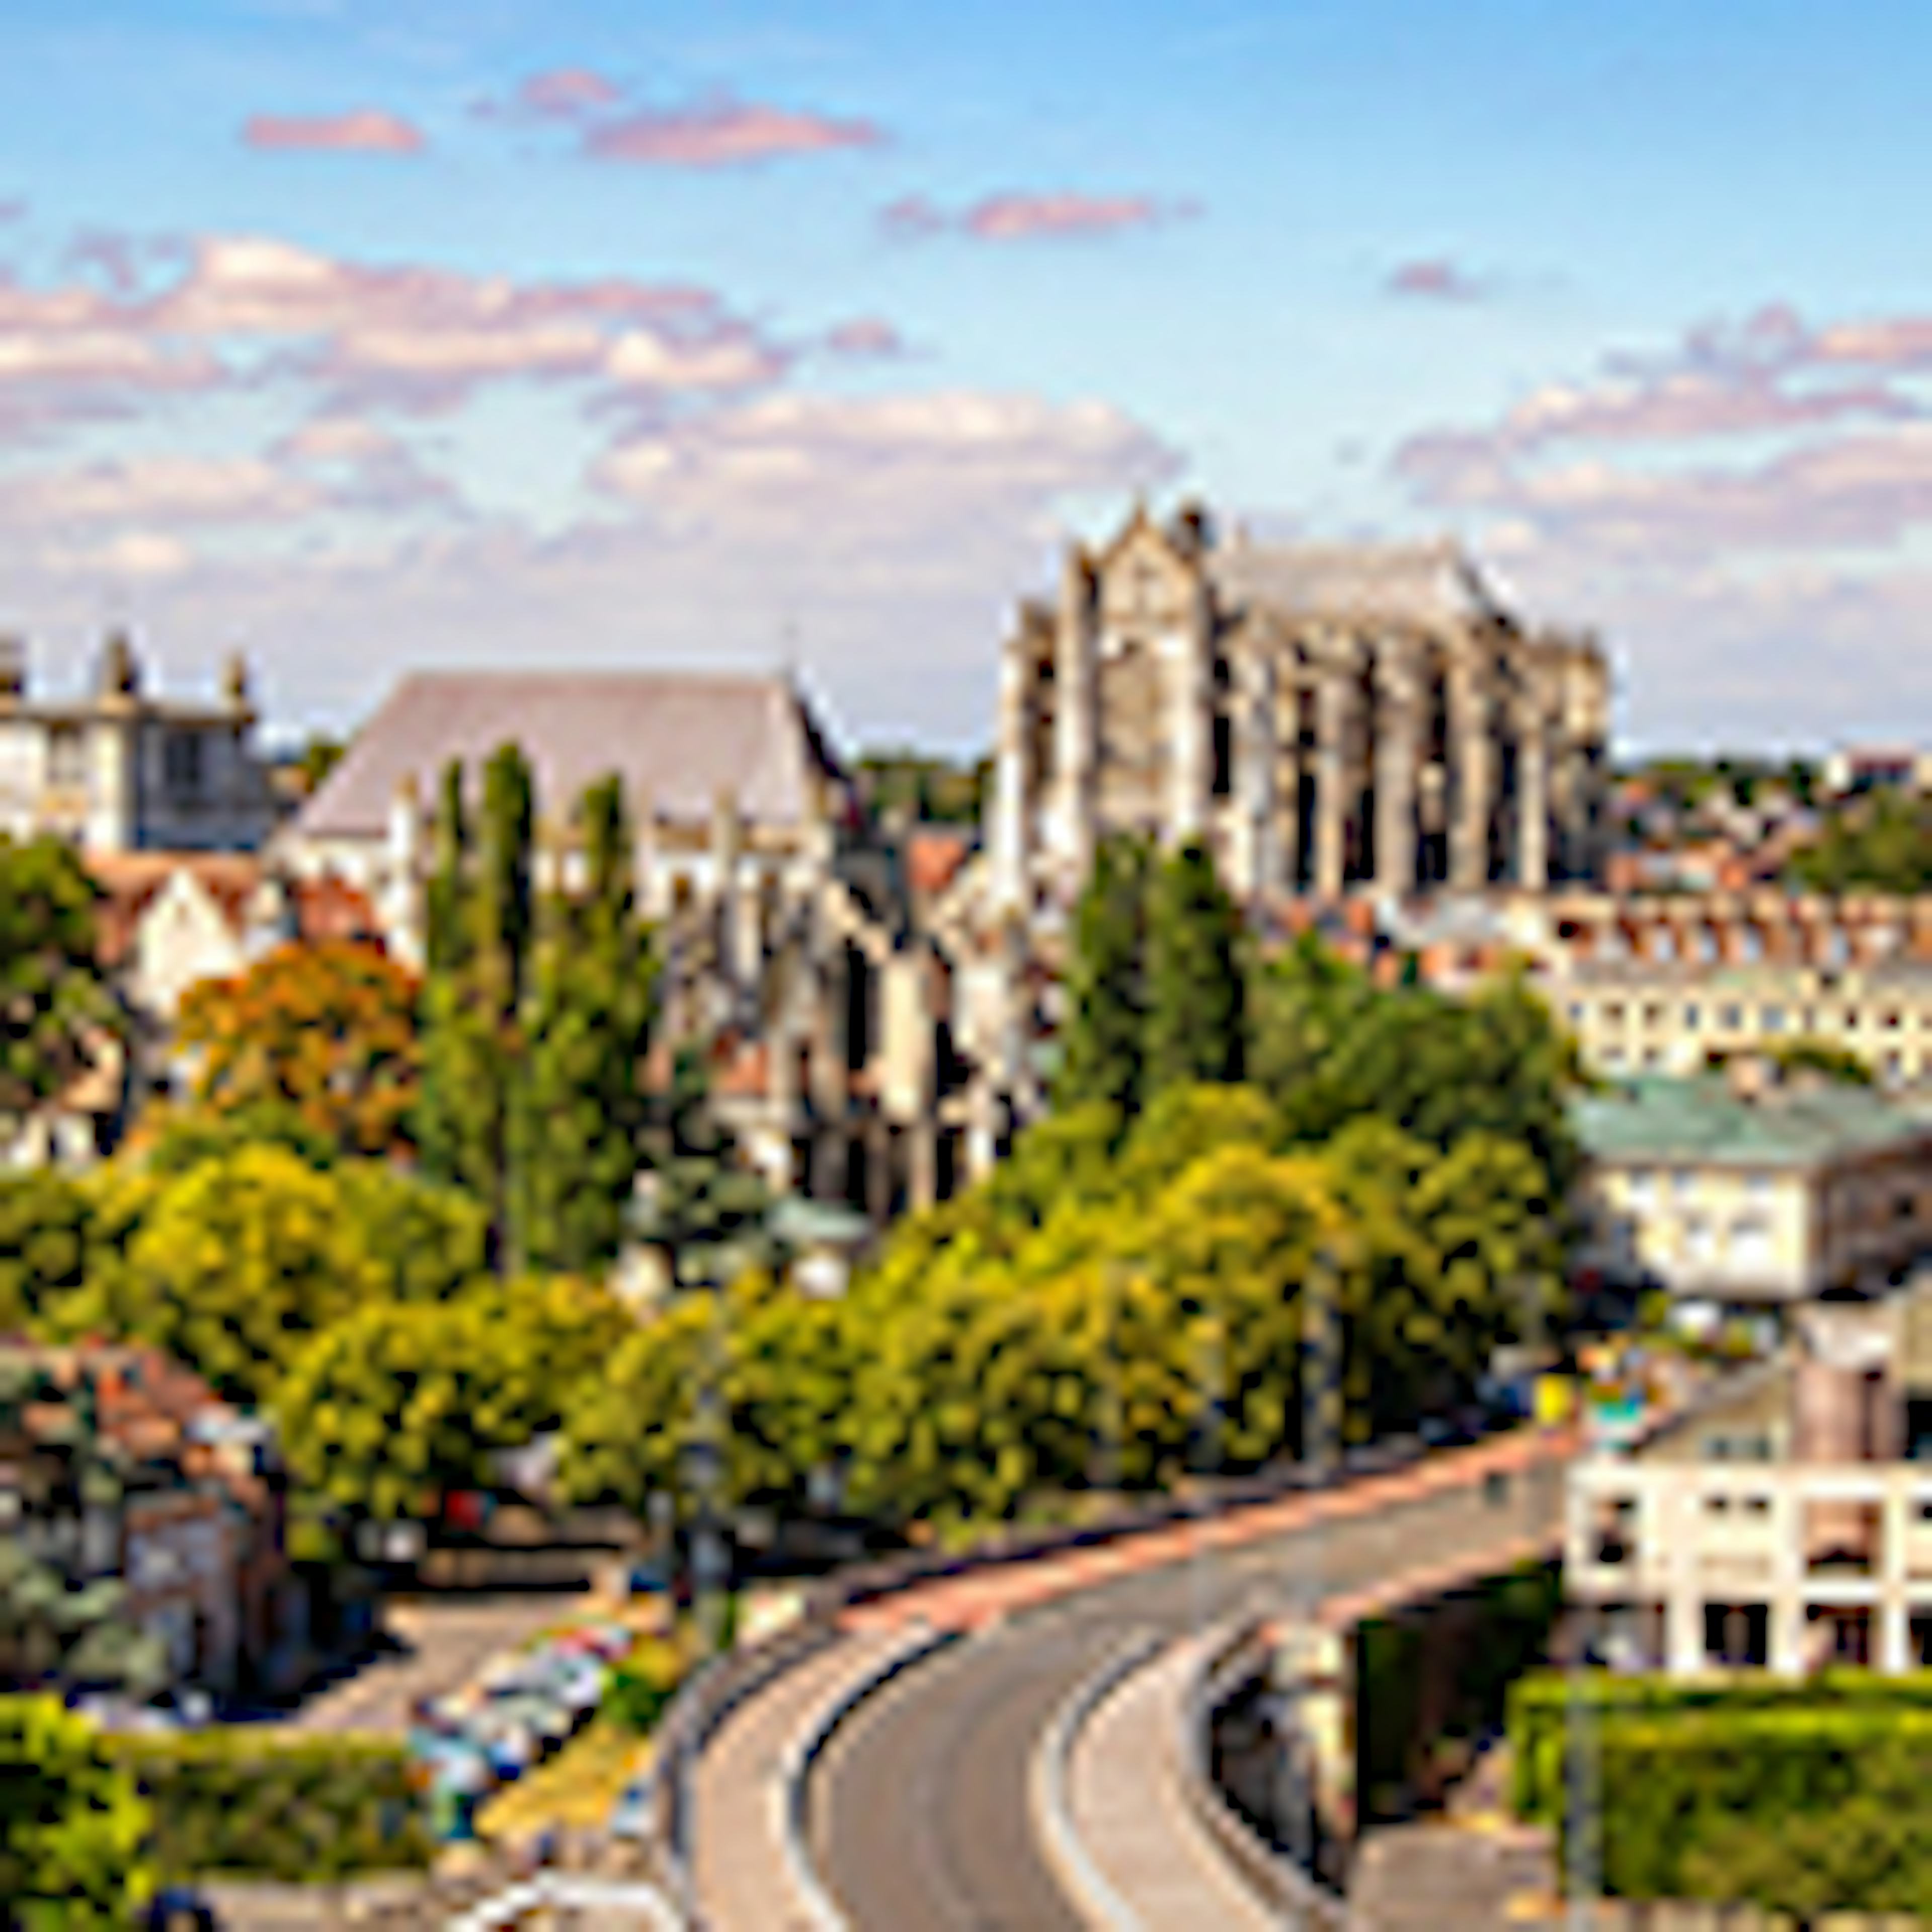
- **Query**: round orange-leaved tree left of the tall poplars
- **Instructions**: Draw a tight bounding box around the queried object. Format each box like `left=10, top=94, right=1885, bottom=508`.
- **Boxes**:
left=178, top=939, right=421, bottom=1153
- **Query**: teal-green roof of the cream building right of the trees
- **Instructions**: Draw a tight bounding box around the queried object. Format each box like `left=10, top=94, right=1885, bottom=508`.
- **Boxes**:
left=1571, top=1074, right=1932, bottom=1167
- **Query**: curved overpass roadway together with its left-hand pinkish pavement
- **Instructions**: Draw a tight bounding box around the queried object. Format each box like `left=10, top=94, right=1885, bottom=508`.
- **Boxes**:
left=690, top=1431, right=1571, bottom=1932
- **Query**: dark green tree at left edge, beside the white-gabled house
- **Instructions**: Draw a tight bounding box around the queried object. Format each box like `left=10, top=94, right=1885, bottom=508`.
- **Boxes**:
left=0, top=833, right=126, bottom=1120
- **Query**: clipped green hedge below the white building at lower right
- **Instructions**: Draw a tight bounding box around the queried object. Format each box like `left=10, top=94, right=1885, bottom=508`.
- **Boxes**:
left=1509, top=1671, right=1932, bottom=1911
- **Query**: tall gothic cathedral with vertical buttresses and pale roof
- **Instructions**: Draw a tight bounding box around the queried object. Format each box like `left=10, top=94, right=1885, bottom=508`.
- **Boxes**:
left=989, top=510, right=1609, bottom=916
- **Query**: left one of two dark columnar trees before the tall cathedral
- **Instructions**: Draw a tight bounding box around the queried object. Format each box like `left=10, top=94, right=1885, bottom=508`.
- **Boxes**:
left=1053, top=837, right=1150, bottom=1120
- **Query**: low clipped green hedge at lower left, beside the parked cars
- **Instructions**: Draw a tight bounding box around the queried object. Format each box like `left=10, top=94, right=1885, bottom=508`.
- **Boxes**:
left=108, top=1729, right=435, bottom=1882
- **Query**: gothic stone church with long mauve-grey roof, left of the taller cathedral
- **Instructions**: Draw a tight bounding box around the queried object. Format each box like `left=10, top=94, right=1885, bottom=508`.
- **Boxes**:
left=274, top=672, right=1037, bottom=1221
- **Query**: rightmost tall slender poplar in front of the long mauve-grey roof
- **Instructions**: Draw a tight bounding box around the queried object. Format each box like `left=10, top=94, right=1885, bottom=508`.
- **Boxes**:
left=512, top=777, right=651, bottom=1271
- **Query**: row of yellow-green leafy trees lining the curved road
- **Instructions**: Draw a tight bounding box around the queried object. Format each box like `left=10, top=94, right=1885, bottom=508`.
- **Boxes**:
left=562, top=1086, right=1563, bottom=1522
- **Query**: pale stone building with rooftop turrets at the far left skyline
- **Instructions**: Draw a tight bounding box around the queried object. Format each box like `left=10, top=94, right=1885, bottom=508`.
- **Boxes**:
left=0, top=635, right=272, bottom=852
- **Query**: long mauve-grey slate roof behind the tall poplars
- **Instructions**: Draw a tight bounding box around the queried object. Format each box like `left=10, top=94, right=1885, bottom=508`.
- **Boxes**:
left=296, top=670, right=837, bottom=839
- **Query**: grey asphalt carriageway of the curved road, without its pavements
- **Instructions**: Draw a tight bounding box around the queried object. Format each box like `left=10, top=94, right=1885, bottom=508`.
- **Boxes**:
left=808, top=1445, right=1559, bottom=1932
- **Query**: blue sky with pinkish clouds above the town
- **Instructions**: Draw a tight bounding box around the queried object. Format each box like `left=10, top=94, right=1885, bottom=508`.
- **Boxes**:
left=0, top=0, right=1932, bottom=748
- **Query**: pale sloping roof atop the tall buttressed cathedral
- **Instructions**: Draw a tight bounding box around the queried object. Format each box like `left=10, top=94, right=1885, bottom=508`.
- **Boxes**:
left=1205, top=535, right=1501, bottom=626
